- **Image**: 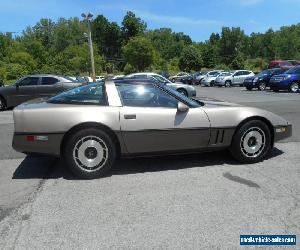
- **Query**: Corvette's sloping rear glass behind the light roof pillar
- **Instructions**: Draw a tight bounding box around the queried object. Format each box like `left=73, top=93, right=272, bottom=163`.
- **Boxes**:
left=47, top=83, right=107, bottom=105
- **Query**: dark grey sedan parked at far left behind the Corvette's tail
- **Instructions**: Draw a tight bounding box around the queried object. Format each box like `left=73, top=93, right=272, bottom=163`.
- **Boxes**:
left=0, top=75, right=82, bottom=110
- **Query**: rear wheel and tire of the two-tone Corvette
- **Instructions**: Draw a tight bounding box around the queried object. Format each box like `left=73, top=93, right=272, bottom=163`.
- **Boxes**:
left=63, top=128, right=116, bottom=179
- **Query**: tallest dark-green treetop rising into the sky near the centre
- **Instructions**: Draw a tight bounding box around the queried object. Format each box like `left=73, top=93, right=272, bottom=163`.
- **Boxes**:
left=122, top=11, right=147, bottom=41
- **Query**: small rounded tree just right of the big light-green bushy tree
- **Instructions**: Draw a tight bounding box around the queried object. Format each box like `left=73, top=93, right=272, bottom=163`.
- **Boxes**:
left=179, top=45, right=203, bottom=72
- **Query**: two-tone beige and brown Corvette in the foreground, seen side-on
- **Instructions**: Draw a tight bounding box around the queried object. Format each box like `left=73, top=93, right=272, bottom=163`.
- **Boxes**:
left=13, top=79, right=292, bottom=179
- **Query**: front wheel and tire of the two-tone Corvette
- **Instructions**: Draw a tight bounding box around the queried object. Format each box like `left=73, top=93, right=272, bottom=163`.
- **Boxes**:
left=230, top=120, right=272, bottom=163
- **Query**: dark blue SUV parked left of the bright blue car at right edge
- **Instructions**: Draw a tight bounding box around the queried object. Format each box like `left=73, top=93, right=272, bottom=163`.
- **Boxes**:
left=244, top=68, right=286, bottom=90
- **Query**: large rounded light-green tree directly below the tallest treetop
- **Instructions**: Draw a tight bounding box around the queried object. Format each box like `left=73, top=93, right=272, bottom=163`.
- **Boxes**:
left=122, top=36, right=155, bottom=71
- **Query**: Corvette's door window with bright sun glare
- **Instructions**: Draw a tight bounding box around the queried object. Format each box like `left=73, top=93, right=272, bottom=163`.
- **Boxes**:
left=116, top=84, right=178, bottom=108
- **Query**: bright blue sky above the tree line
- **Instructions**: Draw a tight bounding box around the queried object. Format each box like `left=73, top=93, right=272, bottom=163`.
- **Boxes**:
left=0, top=0, right=300, bottom=42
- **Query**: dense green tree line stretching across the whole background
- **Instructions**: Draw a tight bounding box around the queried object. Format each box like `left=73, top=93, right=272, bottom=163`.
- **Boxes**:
left=0, top=11, right=300, bottom=82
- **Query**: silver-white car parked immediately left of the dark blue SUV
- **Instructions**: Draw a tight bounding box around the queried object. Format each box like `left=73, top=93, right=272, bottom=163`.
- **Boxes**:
left=215, top=70, right=255, bottom=87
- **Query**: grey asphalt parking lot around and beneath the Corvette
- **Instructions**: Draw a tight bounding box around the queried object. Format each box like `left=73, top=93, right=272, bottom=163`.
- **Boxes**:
left=0, top=86, right=300, bottom=249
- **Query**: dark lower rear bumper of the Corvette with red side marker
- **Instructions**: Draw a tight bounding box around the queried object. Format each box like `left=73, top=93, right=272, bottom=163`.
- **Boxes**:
left=12, top=133, right=64, bottom=156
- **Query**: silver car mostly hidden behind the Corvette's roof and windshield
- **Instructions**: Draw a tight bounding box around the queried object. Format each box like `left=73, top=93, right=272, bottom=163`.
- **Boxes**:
left=126, top=72, right=196, bottom=97
